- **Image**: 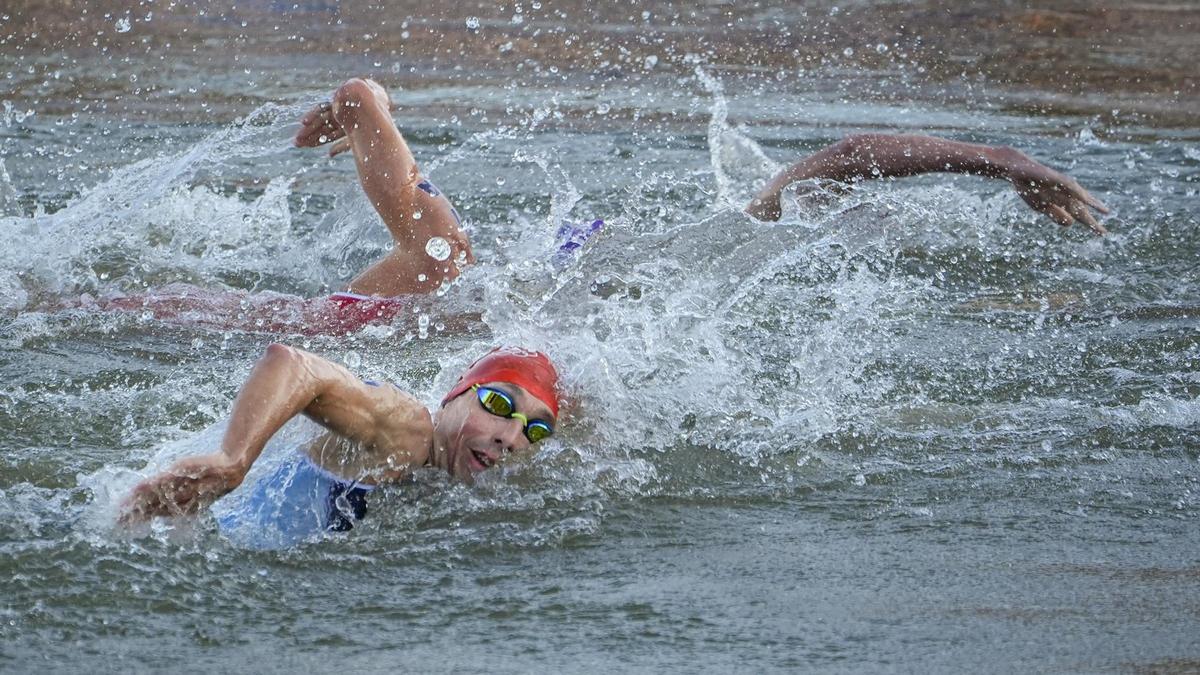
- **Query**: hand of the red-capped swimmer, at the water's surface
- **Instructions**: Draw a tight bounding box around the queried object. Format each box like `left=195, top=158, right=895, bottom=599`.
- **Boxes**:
left=118, top=454, right=245, bottom=525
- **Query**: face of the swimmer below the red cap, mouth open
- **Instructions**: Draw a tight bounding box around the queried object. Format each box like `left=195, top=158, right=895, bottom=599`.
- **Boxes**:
left=433, top=382, right=554, bottom=480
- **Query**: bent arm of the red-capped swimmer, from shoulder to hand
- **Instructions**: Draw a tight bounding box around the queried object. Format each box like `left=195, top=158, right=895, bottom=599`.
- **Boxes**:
left=120, top=345, right=432, bottom=522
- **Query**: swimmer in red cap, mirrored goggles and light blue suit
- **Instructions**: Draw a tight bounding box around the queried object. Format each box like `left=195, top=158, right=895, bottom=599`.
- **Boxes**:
left=120, top=345, right=559, bottom=533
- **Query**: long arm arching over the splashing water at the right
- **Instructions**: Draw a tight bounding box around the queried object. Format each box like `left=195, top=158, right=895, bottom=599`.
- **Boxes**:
left=746, top=133, right=1109, bottom=234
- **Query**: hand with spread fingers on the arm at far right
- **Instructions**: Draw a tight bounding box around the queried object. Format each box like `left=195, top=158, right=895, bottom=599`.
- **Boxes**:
left=1003, top=149, right=1109, bottom=235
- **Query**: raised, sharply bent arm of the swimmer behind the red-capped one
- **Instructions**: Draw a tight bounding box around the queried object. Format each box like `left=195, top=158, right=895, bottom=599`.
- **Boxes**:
left=295, top=78, right=474, bottom=297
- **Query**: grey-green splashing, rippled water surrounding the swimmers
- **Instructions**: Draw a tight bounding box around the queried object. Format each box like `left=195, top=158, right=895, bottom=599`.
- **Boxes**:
left=0, top=31, right=1200, bottom=671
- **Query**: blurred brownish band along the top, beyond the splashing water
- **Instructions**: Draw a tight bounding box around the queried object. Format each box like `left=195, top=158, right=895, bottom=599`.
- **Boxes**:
left=0, top=0, right=1200, bottom=127
